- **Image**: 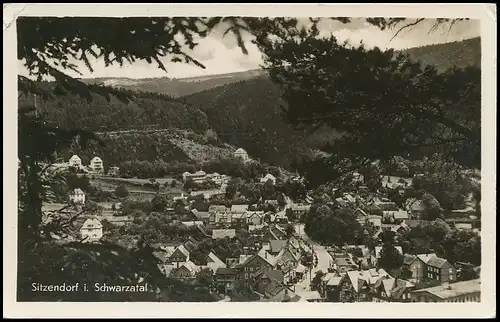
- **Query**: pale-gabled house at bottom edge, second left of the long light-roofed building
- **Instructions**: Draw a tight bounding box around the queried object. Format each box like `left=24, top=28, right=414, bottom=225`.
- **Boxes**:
left=339, top=268, right=390, bottom=302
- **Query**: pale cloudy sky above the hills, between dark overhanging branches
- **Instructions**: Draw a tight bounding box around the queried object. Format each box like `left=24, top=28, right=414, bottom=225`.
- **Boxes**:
left=19, top=18, right=480, bottom=79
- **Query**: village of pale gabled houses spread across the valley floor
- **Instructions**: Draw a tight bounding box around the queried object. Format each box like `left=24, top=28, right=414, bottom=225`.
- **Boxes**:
left=43, top=148, right=480, bottom=302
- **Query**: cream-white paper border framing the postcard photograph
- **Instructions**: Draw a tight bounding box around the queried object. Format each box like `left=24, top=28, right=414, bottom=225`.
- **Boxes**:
left=3, top=3, right=496, bottom=318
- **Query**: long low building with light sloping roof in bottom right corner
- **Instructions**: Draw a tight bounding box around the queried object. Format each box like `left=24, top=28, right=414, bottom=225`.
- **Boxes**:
left=411, top=279, right=481, bottom=303
